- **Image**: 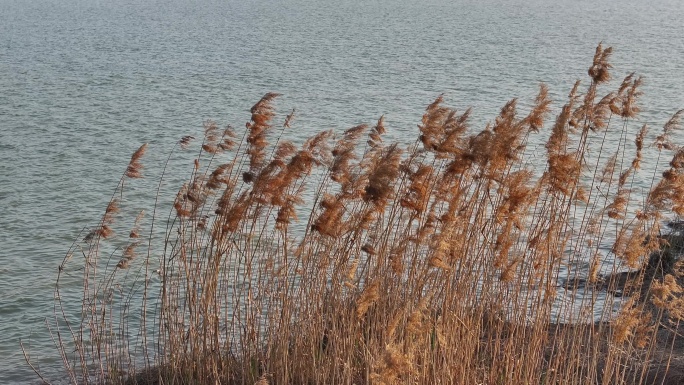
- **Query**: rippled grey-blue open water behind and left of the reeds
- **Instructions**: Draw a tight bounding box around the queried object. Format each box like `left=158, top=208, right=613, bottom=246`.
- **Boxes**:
left=0, top=0, right=684, bottom=384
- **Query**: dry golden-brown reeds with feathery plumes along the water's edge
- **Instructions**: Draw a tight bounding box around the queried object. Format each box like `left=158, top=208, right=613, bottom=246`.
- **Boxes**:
left=34, top=45, right=684, bottom=385
